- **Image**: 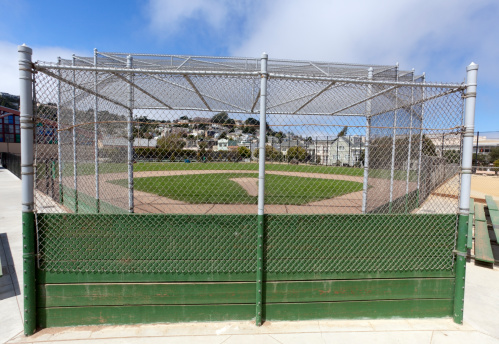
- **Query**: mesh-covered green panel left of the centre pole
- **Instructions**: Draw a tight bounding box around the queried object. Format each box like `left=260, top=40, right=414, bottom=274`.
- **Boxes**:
left=38, top=214, right=257, bottom=280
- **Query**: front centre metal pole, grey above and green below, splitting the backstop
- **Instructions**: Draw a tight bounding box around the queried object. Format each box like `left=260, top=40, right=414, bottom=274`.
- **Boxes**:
left=256, top=53, right=270, bottom=326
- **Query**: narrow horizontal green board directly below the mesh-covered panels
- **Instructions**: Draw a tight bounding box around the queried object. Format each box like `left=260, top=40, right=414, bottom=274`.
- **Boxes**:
left=36, top=269, right=455, bottom=284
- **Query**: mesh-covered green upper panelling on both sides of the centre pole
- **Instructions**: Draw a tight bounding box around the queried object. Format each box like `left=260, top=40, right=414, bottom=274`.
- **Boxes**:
left=38, top=214, right=455, bottom=281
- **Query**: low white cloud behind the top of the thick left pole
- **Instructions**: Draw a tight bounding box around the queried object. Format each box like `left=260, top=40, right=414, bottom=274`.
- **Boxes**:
left=0, top=41, right=82, bottom=95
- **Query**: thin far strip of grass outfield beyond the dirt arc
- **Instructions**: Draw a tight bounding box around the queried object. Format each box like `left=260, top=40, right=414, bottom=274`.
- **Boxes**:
left=46, top=162, right=417, bottom=181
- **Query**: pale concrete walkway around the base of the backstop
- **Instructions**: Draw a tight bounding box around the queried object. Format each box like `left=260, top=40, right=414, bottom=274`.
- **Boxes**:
left=0, top=168, right=499, bottom=344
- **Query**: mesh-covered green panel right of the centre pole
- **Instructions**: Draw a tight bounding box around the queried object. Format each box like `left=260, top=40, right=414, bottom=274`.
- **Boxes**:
left=265, top=214, right=456, bottom=279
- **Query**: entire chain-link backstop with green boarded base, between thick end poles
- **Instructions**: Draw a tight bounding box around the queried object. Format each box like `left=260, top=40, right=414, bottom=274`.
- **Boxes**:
left=19, top=47, right=480, bottom=327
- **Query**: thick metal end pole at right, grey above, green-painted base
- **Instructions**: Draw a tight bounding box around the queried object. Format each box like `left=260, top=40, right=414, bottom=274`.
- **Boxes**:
left=454, top=62, right=478, bottom=324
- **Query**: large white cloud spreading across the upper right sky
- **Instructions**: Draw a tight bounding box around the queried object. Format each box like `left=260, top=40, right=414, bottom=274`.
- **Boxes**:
left=231, top=0, right=499, bottom=81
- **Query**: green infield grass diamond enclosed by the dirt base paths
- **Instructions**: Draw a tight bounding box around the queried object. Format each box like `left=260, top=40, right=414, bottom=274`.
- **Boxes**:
left=112, top=173, right=362, bottom=205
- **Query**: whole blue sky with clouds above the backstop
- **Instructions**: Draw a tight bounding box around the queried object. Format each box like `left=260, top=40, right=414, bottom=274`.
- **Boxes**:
left=0, top=0, right=499, bottom=132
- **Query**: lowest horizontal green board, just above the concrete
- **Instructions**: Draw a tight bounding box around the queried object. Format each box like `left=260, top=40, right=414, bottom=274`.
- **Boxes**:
left=37, top=299, right=453, bottom=328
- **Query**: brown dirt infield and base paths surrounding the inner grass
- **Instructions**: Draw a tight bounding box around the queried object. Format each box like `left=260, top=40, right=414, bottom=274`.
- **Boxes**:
left=58, top=170, right=416, bottom=214
